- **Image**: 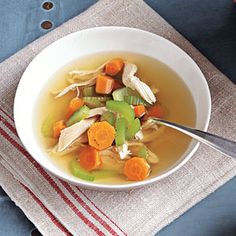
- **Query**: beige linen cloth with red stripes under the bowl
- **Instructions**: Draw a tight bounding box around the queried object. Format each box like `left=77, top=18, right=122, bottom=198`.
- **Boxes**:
left=0, top=0, right=236, bottom=235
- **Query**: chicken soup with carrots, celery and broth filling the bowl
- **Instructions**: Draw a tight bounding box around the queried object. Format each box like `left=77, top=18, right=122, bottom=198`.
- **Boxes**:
left=35, top=52, right=196, bottom=184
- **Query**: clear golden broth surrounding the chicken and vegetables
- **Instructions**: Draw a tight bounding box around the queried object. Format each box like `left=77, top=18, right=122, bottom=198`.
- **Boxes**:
left=35, top=52, right=196, bottom=184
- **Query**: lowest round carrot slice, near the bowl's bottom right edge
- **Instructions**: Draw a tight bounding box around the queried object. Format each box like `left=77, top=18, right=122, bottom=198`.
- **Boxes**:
left=124, top=157, right=150, bottom=181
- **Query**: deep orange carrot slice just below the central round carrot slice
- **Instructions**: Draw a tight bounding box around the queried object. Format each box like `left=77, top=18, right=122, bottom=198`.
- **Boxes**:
left=79, top=147, right=102, bottom=171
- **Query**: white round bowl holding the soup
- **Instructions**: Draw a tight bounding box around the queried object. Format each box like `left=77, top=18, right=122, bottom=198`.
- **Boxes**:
left=14, top=27, right=211, bottom=190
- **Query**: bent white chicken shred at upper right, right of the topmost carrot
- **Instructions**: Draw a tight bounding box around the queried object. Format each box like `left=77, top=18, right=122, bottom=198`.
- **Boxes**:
left=122, top=63, right=156, bottom=104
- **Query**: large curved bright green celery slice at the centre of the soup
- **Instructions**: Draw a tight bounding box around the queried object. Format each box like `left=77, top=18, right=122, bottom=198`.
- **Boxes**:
left=106, top=100, right=135, bottom=125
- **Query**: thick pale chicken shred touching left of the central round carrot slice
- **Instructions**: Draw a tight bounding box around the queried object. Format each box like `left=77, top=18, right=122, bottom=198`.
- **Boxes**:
left=58, top=117, right=97, bottom=152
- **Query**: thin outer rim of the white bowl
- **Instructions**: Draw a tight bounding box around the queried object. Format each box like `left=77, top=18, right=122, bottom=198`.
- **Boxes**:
left=13, top=26, right=212, bottom=191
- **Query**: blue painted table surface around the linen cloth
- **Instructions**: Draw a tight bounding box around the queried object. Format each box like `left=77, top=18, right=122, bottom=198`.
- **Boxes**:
left=0, top=0, right=236, bottom=236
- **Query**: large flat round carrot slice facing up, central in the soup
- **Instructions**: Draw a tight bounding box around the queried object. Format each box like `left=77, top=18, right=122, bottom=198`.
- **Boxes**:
left=87, top=121, right=115, bottom=150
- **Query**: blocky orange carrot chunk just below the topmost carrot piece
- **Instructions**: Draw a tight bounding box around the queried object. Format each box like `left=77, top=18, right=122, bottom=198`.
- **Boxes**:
left=96, top=75, right=115, bottom=94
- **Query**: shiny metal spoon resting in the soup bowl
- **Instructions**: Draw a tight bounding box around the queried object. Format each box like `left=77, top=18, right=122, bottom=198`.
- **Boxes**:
left=152, top=118, right=236, bottom=158
